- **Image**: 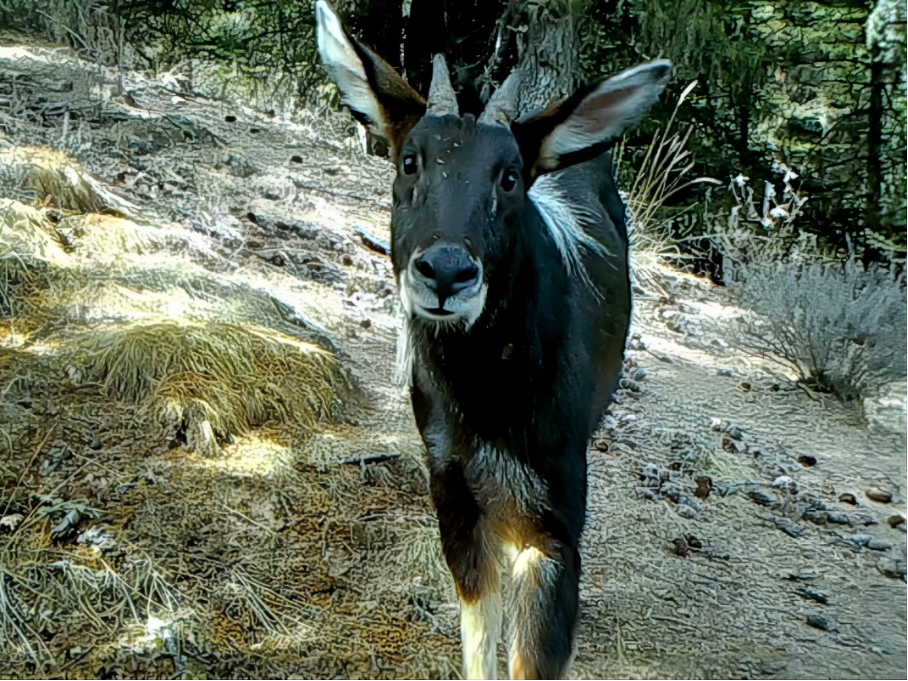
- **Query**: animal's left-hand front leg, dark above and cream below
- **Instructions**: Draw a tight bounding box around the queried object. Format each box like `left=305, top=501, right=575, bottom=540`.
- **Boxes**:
left=432, top=463, right=501, bottom=679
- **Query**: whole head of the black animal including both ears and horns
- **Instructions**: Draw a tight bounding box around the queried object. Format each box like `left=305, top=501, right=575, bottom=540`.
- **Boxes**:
left=316, top=0, right=671, bottom=328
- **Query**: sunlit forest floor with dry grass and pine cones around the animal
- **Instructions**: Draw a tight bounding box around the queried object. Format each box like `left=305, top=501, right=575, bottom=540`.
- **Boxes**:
left=0, top=38, right=906, bottom=678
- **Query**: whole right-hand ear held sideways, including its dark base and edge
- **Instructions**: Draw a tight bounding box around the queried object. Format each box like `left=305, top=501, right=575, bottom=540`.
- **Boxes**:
left=511, top=59, right=672, bottom=178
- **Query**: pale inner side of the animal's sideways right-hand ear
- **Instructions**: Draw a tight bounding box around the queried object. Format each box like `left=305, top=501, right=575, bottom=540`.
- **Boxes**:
left=537, top=59, right=672, bottom=169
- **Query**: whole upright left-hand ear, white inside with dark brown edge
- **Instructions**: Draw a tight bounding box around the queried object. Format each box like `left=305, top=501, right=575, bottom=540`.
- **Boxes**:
left=315, top=0, right=426, bottom=155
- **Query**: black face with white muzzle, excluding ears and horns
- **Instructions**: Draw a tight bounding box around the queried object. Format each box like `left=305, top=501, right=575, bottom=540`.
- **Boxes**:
left=391, top=114, right=526, bottom=326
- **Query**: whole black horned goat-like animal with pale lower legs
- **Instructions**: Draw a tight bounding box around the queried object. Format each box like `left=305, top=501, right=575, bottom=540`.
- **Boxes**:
left=316, top=0, right=671, bottom=679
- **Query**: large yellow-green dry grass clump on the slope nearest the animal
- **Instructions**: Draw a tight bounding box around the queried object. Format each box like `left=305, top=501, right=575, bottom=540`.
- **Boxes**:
left=79, top=322, right=343, bottom=451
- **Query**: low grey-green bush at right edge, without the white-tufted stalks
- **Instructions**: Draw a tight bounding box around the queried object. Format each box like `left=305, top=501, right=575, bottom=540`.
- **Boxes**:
left=730, top=258, right=908, bottom=400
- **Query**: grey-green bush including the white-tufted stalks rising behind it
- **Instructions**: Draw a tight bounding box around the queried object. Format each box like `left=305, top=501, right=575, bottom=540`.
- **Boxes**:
left=714, top=166, right=908, bottom=400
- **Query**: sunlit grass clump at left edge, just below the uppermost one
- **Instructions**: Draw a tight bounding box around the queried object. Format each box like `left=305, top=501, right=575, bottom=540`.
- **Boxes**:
left=0, top=199, right=69, bottom=320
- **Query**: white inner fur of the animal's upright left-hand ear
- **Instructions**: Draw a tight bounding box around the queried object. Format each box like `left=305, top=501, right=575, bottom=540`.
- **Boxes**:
left=315, top=0, right=387, bottom=137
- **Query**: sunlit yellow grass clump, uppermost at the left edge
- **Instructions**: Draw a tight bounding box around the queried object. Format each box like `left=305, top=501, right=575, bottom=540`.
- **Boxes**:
left=0, top=146, right=104, bottom=213
